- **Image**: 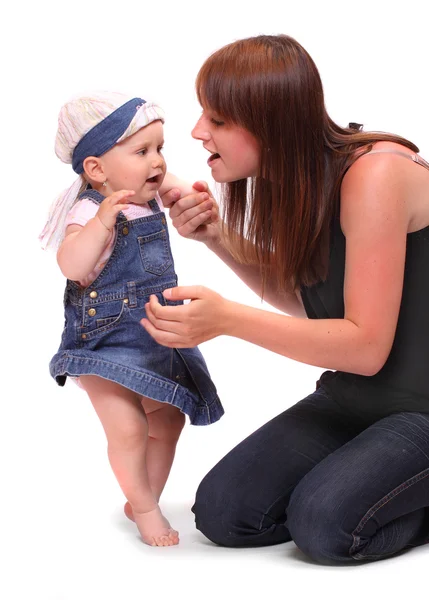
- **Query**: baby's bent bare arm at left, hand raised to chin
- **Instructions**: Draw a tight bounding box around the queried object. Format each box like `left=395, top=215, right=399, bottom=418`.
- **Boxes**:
left=57, top=190, right=135, bottom=281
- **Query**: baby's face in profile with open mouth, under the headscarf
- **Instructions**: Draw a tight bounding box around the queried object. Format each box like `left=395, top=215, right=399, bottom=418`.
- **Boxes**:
left=102, top=121, right=167, bottom=204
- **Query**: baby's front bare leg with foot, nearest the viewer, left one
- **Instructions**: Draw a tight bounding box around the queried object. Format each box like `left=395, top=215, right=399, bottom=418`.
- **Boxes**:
left=80, top=375, right=179, bottom=546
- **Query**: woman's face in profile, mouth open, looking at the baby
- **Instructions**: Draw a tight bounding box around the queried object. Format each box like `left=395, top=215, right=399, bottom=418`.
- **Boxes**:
left=192, top=109, right=260, bottom=183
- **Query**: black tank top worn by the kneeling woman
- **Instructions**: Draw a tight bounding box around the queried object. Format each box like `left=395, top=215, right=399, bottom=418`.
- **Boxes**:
left=301, top=150, right=429, bottom=418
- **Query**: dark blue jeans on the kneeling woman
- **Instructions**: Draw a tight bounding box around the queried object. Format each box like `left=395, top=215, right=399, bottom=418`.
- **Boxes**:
left=192, top=386, right=429, bottom=564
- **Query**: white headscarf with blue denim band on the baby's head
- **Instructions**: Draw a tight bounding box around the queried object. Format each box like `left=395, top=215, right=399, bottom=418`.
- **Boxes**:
left=39, top=92, right=164, bottom=250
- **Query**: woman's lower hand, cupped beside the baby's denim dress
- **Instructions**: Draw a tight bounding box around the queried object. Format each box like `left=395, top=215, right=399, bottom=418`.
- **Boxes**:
left=140, top=285, right=231, bottom=348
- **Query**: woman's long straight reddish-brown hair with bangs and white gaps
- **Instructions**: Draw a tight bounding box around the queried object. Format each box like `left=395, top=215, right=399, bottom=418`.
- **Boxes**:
left=196, top=35, right=418, bottom=291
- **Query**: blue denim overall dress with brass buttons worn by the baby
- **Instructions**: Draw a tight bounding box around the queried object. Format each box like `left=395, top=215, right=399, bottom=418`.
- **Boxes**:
left=50, top=189, right=224, bottom=425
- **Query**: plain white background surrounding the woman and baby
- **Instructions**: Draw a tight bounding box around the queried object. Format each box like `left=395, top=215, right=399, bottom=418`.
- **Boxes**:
left=0, top=0, right=429, bottom=600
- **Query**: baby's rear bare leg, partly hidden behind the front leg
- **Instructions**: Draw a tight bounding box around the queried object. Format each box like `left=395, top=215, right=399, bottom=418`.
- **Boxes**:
left=124, top=398, right=185, bottom=519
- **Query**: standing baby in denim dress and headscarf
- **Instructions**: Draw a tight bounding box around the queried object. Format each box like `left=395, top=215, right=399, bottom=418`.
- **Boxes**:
left=41, top=93, right=223, bottom=546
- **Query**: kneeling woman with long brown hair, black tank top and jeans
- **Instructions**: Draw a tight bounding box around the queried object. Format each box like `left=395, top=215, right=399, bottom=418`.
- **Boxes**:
left=142, top=35, right=429, bottom=563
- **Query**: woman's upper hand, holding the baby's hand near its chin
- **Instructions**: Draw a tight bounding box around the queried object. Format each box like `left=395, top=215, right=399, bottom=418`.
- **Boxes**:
left=162, top=181, right=220, bottom=244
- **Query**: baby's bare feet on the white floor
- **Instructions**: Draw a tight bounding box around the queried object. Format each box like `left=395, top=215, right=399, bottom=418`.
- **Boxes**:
left=124, top=502, right=179, bottom=546
